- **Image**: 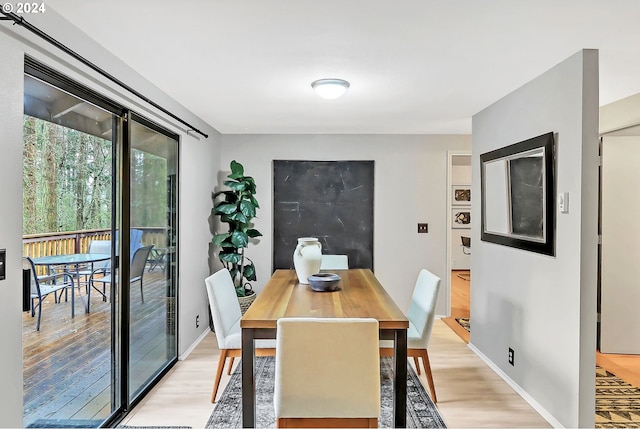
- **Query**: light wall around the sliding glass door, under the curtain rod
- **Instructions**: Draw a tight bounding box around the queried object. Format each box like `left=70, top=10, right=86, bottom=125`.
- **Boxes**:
left=0, top=9, right=220, bottom=427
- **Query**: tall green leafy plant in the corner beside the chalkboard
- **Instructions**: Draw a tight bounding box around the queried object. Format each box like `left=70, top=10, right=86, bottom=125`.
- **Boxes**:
left=212, top=160, right=262, bottom=296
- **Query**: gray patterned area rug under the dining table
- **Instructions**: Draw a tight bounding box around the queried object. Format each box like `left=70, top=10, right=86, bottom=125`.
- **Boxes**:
left=206, top=356, right=447, bottom=429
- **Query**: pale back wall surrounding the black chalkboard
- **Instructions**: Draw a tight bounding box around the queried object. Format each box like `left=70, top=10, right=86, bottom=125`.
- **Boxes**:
left=221, top=135, right=470, bottom=314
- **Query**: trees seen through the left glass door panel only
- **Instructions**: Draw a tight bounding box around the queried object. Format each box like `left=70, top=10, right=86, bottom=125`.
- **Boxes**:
left=22, top=115, right=112, bottom=235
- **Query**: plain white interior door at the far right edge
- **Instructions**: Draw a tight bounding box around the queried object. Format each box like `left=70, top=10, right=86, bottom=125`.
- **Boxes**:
left=600, top=136, right=640, bottom=354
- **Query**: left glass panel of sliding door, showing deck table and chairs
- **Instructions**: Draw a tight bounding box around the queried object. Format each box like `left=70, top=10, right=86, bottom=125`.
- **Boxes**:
left=23, top=74, right=120, bottom=427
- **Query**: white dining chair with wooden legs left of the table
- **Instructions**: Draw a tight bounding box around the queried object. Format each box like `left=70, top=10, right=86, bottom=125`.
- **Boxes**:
left=205, top=268, right=276, bottom=403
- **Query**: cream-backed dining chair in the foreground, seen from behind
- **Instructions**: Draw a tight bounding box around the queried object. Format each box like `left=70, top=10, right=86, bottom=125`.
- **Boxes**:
left=273, top=318, right=380, bottom=428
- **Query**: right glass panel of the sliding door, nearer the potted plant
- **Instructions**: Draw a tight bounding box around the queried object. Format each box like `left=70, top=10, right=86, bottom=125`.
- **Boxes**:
left=129, top=115, right=178, bottom=401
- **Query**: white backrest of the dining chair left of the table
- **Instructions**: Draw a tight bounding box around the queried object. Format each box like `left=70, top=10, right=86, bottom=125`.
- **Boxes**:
left=205, top=268, right=242, bottom=349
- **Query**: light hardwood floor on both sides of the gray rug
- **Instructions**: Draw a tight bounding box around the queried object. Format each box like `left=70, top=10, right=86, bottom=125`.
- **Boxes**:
left=123, top=320, right=551, bottom=428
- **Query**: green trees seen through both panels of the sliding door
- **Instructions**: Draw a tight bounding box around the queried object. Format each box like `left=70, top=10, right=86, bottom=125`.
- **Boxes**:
left=22, top=115, right=169, bottom=235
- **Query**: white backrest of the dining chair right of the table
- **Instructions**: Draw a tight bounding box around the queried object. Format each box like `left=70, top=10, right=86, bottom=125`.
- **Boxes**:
left=407, top=269, right=440, bottom=348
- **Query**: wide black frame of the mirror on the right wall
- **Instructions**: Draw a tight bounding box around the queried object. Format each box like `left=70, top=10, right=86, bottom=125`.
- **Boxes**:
left=480, top=132, right=556, bottom=256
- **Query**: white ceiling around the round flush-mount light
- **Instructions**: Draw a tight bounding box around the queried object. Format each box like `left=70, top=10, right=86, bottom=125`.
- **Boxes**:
left=47, top=0, right=640, bottom=134
